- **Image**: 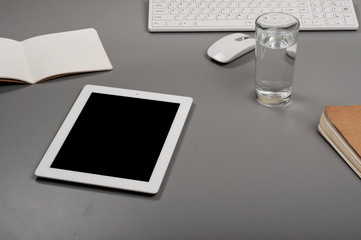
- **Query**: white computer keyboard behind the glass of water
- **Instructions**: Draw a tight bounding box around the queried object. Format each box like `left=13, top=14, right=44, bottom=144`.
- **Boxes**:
left=148, top=0, right=359, bottom=32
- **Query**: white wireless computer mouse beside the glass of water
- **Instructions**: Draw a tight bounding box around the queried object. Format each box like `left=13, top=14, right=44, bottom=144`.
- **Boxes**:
left=207, top=33, right=256, bottom=63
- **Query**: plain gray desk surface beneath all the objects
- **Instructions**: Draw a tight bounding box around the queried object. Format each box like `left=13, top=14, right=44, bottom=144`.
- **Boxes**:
left=0, top=0, right=361, bottom=240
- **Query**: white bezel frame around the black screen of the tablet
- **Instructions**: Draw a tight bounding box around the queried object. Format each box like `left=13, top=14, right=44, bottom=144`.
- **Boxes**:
left=35, top=85, right=193, bottom=194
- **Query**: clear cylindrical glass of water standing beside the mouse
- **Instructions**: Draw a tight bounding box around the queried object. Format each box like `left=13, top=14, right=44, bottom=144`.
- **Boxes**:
left=256, top=13, right=300, bottom=107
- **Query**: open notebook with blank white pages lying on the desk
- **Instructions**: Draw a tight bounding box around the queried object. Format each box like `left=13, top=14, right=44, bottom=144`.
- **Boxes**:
left=0, top=28, right=113, bottom=84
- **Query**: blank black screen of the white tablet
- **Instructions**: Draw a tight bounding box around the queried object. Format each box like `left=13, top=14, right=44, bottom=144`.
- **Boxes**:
left=51, top=93, right=179, bottom=181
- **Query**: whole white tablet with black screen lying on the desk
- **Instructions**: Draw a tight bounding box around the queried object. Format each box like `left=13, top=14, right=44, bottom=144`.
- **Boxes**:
left=35, top=85, right=193, bottom=194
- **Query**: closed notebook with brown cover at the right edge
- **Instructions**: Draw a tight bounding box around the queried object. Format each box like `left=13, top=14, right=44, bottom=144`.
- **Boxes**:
left=318, top=105, right=361, bottom=178
